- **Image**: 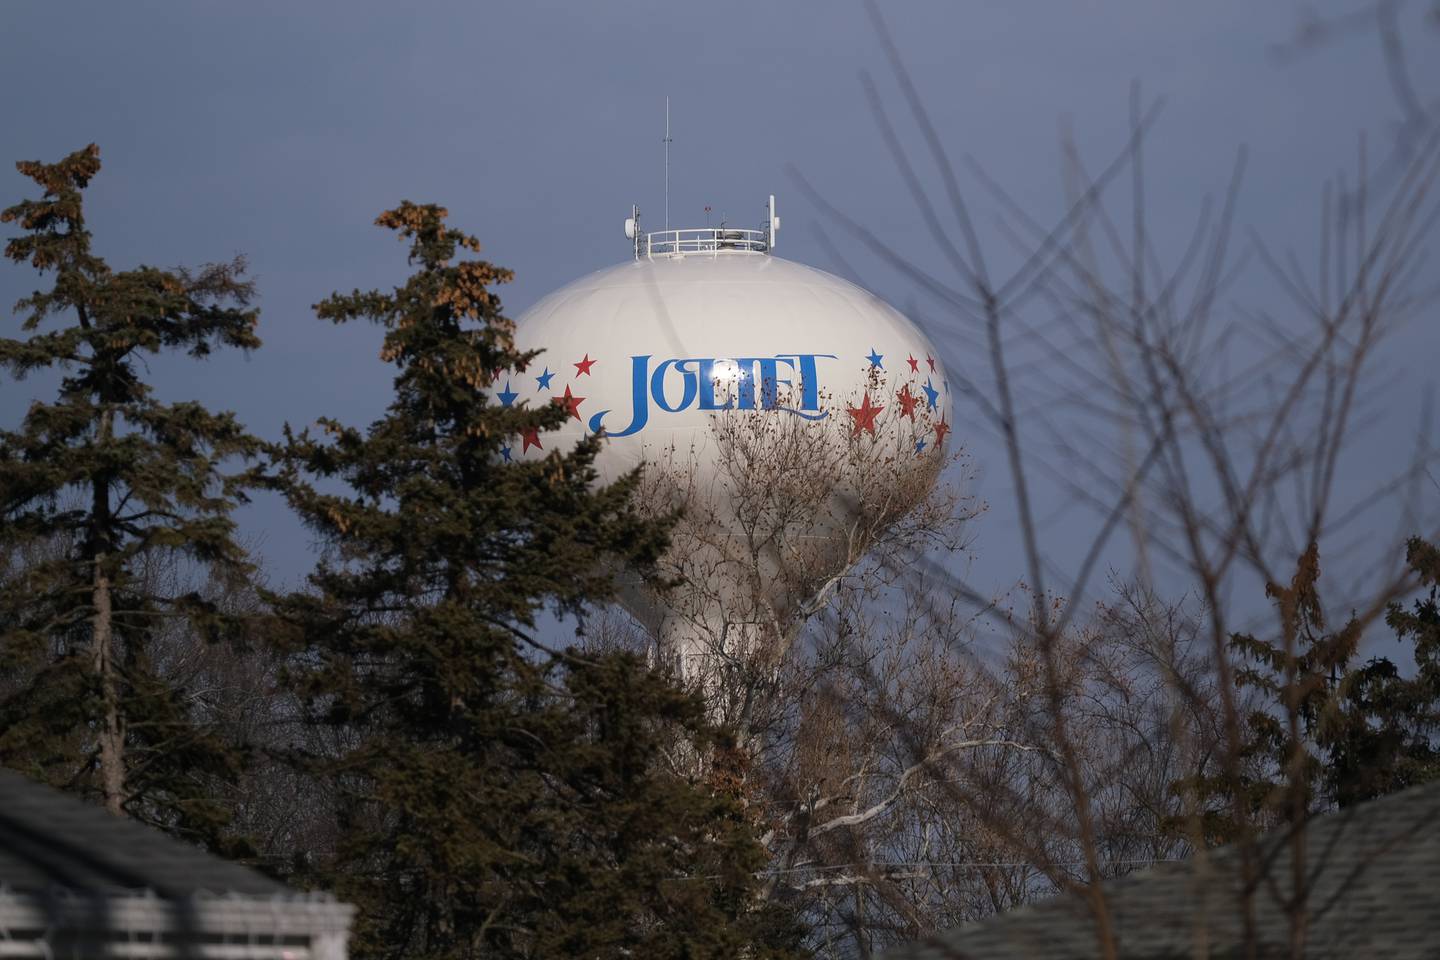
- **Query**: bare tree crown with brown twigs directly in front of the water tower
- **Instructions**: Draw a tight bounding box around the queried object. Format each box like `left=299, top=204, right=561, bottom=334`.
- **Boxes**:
left=622, top=370, right=975, bottom=734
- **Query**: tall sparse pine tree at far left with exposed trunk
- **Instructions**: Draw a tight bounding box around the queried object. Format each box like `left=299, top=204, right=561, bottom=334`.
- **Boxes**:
left=0, top=144, right=261, bottom=843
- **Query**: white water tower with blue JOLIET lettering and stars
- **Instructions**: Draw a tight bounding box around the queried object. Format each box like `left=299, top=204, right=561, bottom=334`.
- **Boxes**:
left=497, top=196, right=950, bottom=690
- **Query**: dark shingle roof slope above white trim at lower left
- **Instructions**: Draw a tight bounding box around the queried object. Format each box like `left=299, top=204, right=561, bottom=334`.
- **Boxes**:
left=0, top=770, right=285, bottom=898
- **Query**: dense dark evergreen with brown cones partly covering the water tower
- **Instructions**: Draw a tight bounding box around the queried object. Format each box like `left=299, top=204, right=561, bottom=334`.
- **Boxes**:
left=275, top=203, right=798, bottom=957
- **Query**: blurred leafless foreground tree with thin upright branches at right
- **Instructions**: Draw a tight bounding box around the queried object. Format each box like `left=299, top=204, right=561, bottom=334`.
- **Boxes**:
left=771, top=7, right=1440, bottom=956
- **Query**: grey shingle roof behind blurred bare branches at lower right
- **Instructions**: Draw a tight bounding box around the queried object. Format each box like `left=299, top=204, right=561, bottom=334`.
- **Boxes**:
left=886, top=783, right=1440, bottom=960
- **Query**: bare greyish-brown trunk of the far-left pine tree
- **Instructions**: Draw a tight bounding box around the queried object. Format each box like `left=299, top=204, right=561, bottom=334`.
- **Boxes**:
left=91, top=407, right=125, bottom=816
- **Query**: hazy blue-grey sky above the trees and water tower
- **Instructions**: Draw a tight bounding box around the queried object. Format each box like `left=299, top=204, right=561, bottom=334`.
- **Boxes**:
left=0, top=0, right=1440, bottom=639
